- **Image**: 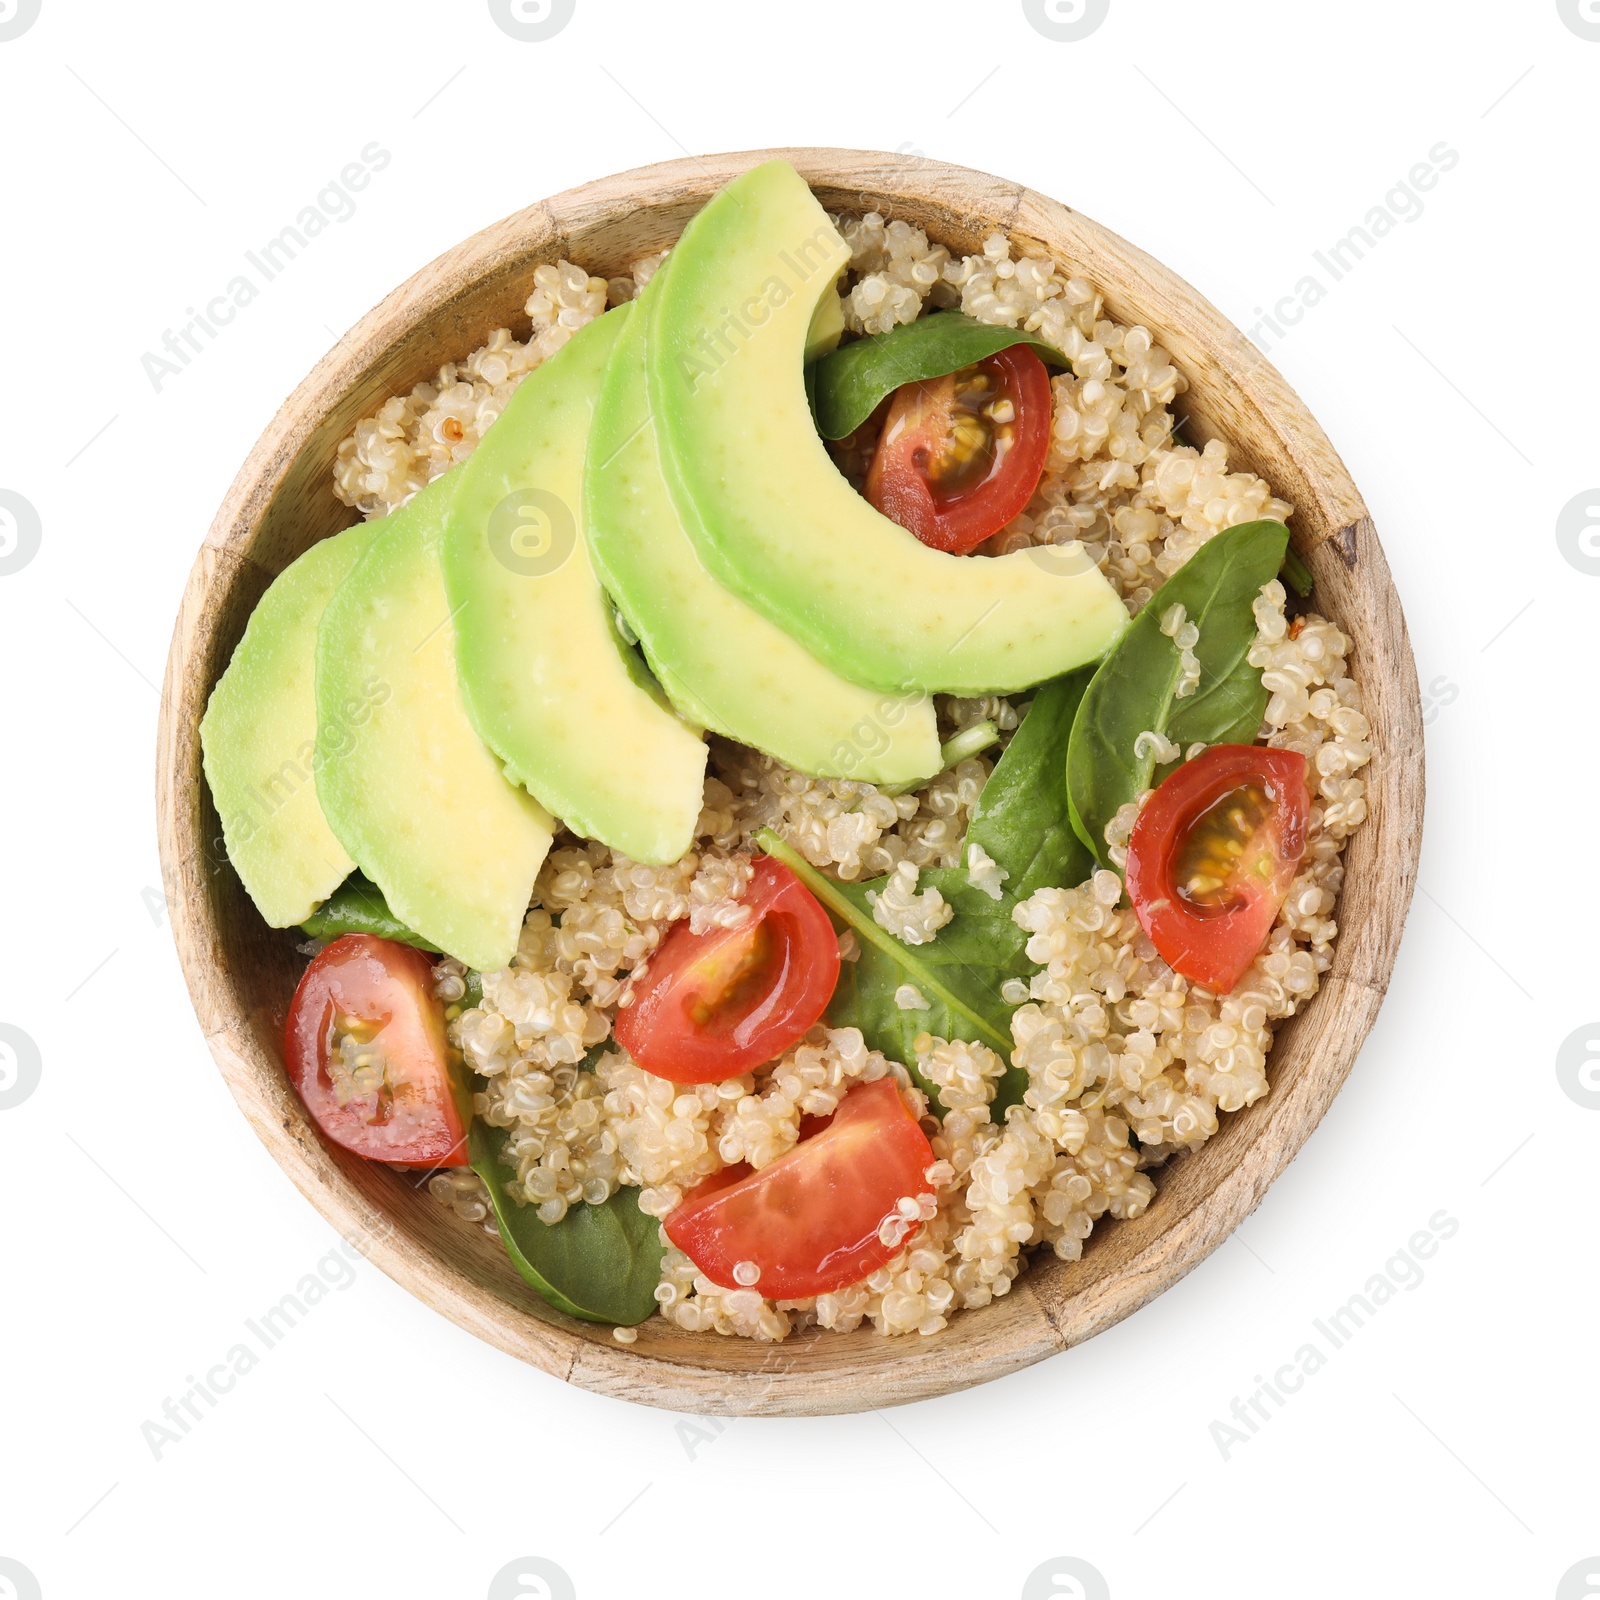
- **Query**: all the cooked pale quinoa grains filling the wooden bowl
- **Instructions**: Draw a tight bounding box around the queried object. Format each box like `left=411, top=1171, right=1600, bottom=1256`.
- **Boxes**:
left=334, top=213, right=1371, bottom=1342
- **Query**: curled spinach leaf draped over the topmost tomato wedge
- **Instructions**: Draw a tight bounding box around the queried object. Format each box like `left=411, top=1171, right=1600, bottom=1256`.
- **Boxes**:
left=806, top=310, right=1072, bottom=438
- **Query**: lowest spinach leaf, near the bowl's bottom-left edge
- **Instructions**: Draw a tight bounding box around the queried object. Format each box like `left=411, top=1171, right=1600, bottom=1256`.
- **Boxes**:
left=467, top=1117, right=662, bottom=1328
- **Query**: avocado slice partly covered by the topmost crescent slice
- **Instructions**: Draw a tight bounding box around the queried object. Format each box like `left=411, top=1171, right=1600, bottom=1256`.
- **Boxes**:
left=584, top=268, right=942, bottom=784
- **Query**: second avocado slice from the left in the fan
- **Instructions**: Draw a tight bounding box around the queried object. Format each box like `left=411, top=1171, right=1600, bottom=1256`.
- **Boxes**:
left=317, top=467, right=555, bottom=971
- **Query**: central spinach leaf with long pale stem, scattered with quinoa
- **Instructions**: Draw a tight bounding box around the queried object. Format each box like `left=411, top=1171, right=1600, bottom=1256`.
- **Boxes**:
left=757, top=669, right=1093, bottom=1118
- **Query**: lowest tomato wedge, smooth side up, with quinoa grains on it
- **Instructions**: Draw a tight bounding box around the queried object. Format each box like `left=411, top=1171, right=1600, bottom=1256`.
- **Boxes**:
left=666, top=1078, right=933, bottom=1299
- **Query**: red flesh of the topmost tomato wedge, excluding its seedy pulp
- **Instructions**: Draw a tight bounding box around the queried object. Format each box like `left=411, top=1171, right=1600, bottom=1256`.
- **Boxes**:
left=866, top=344, right=1051, bottom=555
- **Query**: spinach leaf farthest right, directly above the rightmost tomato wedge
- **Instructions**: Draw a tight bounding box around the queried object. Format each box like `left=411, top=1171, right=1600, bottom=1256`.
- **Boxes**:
left=1067, top=522, right=1290, bottom=864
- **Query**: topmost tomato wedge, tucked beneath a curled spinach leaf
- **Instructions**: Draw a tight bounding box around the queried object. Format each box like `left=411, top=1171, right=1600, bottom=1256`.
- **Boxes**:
left=866, top=344, right=1050, bottom=555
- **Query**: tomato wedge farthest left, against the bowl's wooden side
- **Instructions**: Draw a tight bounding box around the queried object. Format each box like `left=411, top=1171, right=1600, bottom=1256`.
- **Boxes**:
left=283, top=933, right=472, bottom=1166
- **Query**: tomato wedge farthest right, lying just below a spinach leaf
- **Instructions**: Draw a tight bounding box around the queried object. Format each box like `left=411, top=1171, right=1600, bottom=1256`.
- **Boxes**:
left=1126, top=744, right=1307, bottom=995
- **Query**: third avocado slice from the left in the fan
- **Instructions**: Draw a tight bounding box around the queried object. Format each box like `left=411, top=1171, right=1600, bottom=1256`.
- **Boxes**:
left=444, top=307, right=706, bottom=870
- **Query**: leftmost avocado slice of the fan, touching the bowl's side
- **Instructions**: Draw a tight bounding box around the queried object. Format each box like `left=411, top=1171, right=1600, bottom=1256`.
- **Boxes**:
left=200, top=523, right=374, bottom=928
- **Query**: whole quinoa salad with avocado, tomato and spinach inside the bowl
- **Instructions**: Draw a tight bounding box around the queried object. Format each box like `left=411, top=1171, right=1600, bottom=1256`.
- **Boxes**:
left=200, top=162, right=1370, bottom=1344
